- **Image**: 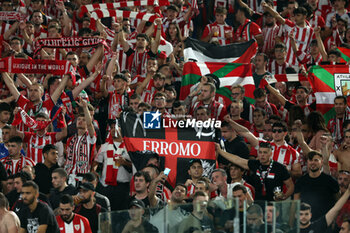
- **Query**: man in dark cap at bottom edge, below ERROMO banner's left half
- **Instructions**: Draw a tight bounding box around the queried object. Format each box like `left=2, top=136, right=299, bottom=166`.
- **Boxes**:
left=122, top=199, right=158, bottom=233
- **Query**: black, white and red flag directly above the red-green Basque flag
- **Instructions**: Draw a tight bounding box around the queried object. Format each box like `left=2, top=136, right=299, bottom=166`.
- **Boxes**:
left=184, top=37, right=258, bottom=63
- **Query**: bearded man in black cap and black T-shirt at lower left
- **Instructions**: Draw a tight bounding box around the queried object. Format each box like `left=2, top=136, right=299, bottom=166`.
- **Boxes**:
left=74, top=182, right=107, bottom=233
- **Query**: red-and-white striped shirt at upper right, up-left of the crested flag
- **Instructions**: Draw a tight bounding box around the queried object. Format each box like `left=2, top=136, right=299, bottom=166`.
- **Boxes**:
left=283, top=19, right=314, bottom=66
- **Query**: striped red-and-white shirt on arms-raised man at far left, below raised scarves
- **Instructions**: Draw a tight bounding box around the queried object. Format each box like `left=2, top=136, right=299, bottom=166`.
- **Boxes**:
left=23, top=132, right=57, bottom=163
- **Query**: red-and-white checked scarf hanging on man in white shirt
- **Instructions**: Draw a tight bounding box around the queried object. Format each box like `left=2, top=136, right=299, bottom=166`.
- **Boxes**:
left=105, top=141, right=125, bottom=186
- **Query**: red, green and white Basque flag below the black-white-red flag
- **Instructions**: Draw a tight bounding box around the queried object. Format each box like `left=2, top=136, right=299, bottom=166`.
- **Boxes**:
left=180, top=62, right=255, bottom=103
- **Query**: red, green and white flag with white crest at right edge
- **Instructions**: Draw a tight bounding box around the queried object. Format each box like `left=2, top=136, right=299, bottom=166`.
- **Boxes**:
left=309, top=65, right=350, bottom=122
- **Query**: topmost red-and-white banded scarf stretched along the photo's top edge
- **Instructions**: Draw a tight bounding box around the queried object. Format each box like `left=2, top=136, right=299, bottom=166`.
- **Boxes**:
left=79, top=0, right=169, bottom=18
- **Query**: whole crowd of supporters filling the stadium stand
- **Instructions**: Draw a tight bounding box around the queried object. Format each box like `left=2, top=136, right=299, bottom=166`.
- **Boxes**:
left=0, top=0, right=350, bottom=233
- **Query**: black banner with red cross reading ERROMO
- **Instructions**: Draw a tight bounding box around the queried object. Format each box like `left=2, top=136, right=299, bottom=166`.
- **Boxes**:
left=120, top=112, right=217, bottom=186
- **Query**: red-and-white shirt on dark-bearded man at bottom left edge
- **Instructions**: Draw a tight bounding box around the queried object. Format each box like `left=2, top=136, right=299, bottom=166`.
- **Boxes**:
left=56, top=213, right=91, bottom=233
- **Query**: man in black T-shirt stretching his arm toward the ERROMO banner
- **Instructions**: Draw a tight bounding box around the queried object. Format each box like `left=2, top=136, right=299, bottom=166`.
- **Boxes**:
left=216, top=142, right=294, bottom=201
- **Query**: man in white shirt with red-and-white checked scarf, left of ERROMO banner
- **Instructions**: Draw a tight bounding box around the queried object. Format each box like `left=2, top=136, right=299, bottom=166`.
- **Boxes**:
left=93, top=120, right=132, bottom=211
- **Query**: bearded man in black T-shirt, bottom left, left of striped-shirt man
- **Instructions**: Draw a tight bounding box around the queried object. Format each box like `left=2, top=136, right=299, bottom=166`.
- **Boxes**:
left=19, top=181, right=60, bottom=233
